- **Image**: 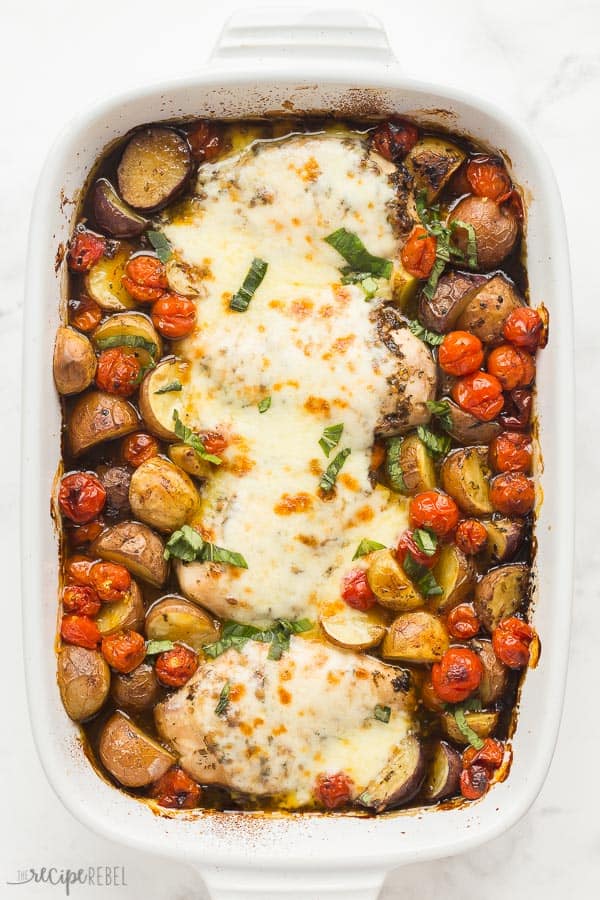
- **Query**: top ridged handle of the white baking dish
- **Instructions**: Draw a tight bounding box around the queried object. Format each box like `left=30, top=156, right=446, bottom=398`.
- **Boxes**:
left=210, top=7, right=397, bottom=67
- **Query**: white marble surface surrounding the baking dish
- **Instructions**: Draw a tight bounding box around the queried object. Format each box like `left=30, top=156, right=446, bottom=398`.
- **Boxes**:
left=0, top=0, right=600, bottom=900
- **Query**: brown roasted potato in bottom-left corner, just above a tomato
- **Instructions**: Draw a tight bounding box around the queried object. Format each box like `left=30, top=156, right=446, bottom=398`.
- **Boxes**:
left=98, top=712, right=176, bottom=787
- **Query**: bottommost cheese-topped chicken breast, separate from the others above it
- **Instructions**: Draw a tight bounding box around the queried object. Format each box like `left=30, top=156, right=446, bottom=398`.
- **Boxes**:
left=155, top=637, right=415, bottom=808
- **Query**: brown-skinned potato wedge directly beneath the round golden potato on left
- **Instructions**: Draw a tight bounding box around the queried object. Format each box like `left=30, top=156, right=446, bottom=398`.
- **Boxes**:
left=90, top=522, right=167, bottom=587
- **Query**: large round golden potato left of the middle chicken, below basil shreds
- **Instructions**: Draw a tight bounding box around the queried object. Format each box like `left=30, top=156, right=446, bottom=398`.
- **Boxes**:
left=129, top=456, right=200, bottom=534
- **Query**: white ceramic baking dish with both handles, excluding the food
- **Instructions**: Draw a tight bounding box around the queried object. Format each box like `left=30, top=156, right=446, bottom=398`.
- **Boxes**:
left=22, top=11, right=573, bottom=900
